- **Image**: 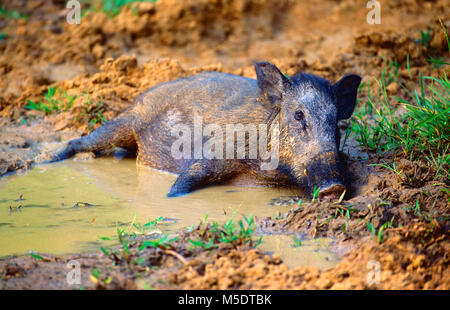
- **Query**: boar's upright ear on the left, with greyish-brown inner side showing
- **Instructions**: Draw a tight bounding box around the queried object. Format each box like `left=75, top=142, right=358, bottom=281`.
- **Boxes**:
left=254, top=62, right=290, bottom=108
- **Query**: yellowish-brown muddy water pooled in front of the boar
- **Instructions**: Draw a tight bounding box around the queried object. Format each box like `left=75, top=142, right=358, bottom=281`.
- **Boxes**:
left=0, top=158, right=334, bottom=267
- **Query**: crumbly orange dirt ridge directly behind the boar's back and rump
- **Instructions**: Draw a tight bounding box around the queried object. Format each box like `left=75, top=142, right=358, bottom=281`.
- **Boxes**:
left=51, top=55, right=221, bottom=133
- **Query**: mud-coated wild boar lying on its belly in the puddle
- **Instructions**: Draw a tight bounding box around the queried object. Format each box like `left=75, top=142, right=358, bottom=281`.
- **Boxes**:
left=37, top=62, right=361, bottom=199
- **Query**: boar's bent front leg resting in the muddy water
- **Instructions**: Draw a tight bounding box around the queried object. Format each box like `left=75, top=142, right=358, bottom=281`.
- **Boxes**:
left=167, top=159, right=238, bottom=197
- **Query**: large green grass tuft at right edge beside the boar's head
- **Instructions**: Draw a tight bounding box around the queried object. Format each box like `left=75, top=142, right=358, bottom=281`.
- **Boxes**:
left=350, top=69, right=450, bottom=179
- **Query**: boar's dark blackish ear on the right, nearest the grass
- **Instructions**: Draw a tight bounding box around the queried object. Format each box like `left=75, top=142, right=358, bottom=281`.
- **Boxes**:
left=333, top=74, right=361, bottom=120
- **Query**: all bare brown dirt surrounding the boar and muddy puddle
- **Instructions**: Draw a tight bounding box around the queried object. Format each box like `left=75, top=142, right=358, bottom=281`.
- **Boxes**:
left=0, top=0, right=450, bottom=289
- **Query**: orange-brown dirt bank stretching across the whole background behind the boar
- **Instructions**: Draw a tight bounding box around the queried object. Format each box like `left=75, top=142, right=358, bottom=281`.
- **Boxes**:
left=0, top=0, right=449, bottom=124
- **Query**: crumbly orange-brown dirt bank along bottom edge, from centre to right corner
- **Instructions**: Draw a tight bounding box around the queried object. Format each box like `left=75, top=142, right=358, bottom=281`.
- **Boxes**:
left=171, top=225, right=450, bottom=289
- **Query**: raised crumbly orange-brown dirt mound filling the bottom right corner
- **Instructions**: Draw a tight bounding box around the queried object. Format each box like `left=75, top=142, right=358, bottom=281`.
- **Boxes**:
left=326, top=223, right=450, bottom=290
